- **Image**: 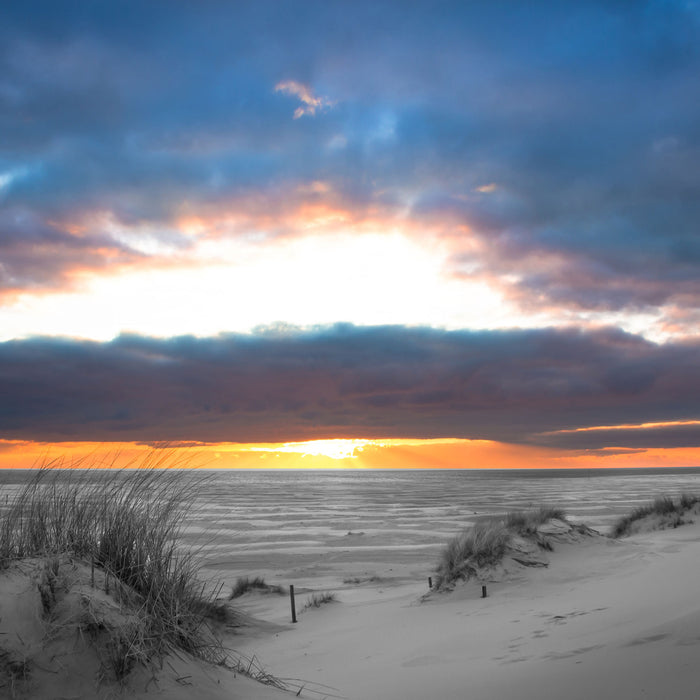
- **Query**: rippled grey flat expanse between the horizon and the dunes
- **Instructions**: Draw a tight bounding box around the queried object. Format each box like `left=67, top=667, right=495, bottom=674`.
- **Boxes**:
left=0, top=467, right=700, bottom=585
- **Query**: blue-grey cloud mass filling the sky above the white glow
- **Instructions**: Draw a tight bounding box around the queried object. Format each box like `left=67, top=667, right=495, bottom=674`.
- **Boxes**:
left=0, top=1, right=700, bottom=320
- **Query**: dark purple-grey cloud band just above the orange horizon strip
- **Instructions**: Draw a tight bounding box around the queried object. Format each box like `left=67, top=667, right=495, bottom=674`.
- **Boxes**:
left=0, top=326, right=700, bottom=448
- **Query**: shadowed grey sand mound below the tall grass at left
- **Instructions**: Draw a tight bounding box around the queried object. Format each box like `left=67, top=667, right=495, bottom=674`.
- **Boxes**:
left=0, top=559, right=289, bottom=700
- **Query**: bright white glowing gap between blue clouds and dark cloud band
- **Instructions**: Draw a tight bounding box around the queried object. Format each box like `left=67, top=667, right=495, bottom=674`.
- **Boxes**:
left=0, top=226, right=540, bottom=340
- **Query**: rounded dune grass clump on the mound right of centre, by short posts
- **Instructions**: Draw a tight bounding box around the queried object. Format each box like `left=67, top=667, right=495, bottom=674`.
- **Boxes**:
left=435, top=506, right=566, bottom=590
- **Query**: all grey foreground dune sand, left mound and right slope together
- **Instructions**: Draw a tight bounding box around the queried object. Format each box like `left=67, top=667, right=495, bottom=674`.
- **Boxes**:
left=0, top=523, right=700, bottom=700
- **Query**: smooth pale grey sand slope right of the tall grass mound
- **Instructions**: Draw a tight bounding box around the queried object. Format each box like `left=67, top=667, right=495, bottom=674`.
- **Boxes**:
left=239, top=524, right=700, bottom=700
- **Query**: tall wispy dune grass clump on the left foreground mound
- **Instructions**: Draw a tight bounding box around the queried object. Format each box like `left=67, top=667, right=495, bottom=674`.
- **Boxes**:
left=0, top=465, right=232, bottom=677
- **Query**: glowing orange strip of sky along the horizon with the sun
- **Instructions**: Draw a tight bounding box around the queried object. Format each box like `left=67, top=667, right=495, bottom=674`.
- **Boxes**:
left=0, top=438, right=700, bottom=469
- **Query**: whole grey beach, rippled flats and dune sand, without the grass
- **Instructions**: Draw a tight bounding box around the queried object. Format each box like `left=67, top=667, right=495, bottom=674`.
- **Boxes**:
left=0, top=470, right=700, bottom=700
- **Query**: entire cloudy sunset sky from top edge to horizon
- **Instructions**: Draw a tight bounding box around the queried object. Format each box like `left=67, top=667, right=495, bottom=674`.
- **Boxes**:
left=0, top=0, right=700, bottom=468
